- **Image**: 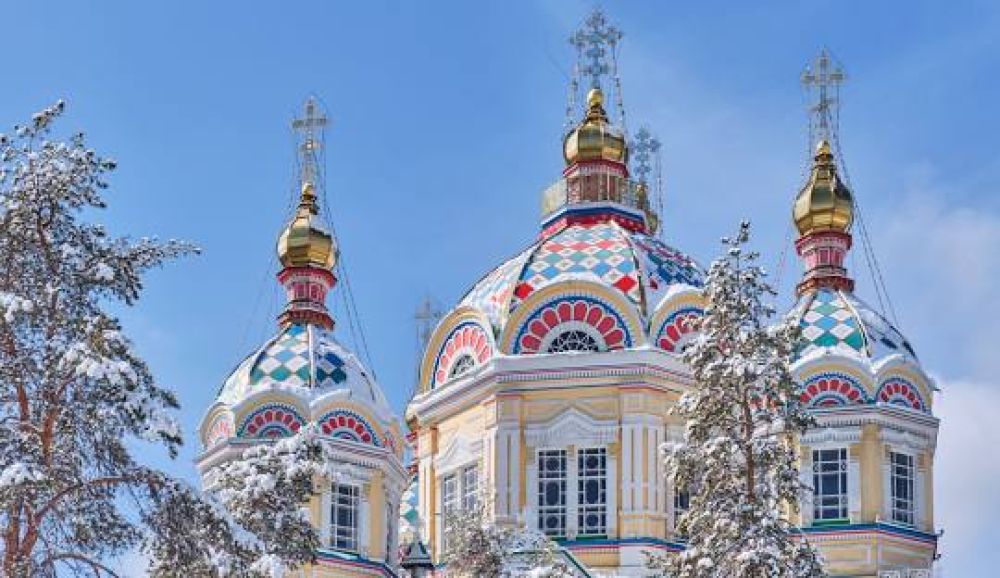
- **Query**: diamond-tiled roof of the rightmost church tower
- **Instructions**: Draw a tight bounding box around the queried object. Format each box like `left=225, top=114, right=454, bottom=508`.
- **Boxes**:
left=797, top=289, right=917, bottom=361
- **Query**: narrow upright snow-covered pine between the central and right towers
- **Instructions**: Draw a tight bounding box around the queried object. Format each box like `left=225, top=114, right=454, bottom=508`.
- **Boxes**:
left=650, top=222, right=825, bottom=578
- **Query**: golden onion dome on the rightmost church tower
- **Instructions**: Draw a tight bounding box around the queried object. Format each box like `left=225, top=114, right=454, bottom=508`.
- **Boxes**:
left=792, top=140, right=854, bottom=235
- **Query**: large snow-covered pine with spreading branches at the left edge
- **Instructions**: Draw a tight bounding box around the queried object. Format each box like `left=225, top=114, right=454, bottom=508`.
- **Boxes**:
left=0, top=102, right=322, bottom=578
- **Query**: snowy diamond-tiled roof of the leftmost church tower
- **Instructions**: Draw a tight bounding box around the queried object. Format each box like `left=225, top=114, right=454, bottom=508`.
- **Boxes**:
left=218, top=325, right=392, bottom=415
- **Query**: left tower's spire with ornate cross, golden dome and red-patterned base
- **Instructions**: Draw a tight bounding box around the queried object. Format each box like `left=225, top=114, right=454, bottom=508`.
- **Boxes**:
left=277, top=97, right=339, bottom=329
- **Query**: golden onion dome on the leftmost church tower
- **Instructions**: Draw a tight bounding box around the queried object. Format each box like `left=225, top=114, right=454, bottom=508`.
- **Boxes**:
left=278, top=182, right=338, bottom=269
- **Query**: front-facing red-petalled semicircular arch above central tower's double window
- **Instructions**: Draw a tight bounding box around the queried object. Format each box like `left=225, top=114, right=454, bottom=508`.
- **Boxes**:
left=512, top=295, right=634, bottom=355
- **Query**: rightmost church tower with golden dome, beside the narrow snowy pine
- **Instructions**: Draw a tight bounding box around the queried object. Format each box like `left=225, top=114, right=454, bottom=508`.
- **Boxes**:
left=792, top=51, right=938, bottom=578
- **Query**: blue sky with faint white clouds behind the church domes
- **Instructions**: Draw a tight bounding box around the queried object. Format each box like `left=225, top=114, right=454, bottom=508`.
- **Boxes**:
left=0, top=1, right=1000, bottom=576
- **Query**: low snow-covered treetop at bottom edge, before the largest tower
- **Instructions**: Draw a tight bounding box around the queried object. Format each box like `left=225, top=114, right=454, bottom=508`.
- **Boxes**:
left=444, top=508, right=575, bottom=578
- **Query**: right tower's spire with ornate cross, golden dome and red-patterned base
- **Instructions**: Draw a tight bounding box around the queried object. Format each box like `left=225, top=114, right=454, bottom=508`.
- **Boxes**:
left=792, top=49, right=854, bottom=295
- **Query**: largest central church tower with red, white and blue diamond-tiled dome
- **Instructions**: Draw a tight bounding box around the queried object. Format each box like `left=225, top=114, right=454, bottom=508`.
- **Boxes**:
left=406, top=11, right=703, bottom=576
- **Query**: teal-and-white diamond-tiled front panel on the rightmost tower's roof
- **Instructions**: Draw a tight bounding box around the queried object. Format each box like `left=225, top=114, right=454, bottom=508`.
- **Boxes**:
left=801, top=289, right=868, bottom=354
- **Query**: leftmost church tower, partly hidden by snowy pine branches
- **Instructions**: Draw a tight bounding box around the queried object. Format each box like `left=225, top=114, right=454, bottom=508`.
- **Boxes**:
left=197, top=99, right=407, bottom=577
